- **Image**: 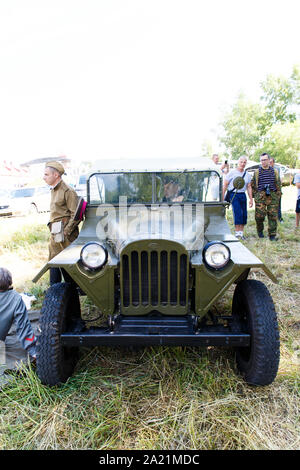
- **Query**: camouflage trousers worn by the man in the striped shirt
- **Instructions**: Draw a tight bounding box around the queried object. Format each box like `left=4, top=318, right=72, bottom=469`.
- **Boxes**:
left=254, top=191, right=280, bottom=237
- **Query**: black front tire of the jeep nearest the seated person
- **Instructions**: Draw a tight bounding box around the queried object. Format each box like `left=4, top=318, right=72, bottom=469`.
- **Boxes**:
left=36, top=283, right=80, bottom=386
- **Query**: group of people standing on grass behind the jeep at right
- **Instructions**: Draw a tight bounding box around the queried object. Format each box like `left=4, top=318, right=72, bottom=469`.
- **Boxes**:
left=212, top=153, right=300, bottom=241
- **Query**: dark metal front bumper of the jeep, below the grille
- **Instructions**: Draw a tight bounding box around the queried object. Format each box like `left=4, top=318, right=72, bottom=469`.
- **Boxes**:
left=61, top=315, right=250, bottom=347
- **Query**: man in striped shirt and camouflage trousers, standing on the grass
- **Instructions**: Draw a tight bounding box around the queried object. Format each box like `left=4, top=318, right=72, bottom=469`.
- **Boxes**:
left=251, top=153, right=281, bottom=241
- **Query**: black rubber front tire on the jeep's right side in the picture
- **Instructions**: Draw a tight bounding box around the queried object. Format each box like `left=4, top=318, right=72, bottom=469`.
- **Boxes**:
left=232, top=280, right=280, bottom=385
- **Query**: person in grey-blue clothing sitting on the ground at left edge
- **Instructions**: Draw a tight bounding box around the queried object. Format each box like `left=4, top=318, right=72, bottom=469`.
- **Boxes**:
left=0, top=268, right=36, bottom=359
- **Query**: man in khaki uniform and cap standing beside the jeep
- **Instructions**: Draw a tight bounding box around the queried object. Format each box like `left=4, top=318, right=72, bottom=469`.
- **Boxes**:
left=44, top=161, right=79, bottom=285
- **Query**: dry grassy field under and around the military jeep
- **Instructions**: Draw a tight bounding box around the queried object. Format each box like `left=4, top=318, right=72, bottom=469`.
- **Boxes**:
left=0, top=188, right=300, bottom=450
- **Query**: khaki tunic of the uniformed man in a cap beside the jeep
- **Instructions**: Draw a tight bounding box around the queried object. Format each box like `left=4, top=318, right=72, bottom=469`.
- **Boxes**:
left=48, top=180, right=79, bottom=260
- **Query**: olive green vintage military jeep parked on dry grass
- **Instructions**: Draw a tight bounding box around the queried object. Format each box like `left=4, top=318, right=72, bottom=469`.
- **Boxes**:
left=34, top=159, right=279, bottom=385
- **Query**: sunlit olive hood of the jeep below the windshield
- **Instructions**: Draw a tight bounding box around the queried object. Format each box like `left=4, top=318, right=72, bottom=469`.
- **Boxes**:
left=92, top=204, right=238, bottom=255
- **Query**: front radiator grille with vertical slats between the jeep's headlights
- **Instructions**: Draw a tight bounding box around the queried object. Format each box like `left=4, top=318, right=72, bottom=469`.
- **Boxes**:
left=121, top=247, right=189, bottom=313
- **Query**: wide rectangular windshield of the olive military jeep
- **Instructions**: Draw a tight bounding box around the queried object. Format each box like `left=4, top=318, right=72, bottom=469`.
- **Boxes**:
left=89, top=171, right=220, bottom=204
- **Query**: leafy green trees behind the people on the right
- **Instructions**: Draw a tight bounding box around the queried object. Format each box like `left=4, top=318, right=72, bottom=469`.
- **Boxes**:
left=203, top=65, right=300, bottom=168
